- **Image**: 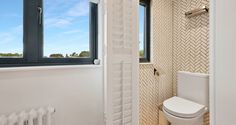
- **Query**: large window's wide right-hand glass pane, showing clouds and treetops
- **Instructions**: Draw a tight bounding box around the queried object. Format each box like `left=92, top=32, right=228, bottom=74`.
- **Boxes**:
left=44, top=0, right=90, bottom=58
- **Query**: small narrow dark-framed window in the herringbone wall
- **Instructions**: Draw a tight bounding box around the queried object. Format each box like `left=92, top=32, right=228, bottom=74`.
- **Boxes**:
left=139, top=0, right=150, bottom=62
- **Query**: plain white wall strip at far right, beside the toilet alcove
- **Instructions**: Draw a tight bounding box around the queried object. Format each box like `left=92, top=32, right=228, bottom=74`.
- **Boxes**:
left=211, top=0, right=236, bottom=125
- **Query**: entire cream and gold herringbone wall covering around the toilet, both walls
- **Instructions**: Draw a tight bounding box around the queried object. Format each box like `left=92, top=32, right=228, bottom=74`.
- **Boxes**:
left=140, top=0, right=209, bottom=125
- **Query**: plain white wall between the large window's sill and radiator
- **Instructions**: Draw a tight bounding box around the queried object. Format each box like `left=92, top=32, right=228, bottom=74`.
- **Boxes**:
left=0, top=66, right=103, bottom=125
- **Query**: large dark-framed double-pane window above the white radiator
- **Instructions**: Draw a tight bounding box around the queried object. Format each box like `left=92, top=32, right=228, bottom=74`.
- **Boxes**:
left=0, top=0, right=98, bottom=66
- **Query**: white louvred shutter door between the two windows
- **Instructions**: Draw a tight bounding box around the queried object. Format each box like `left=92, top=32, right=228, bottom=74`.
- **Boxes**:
left=105, top=0, right=139, bottom=125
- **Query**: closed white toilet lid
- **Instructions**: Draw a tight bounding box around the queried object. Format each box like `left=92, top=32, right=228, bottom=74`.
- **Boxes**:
left=163, top=97, right=205, bottom=118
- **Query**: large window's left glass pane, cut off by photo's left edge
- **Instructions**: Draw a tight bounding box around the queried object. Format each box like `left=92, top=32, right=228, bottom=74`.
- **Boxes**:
left=0, top=0, right=23, bottom=58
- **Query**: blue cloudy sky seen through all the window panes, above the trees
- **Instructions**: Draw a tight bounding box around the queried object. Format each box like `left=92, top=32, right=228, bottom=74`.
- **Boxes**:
left=0, top=0, right=144, bottom=56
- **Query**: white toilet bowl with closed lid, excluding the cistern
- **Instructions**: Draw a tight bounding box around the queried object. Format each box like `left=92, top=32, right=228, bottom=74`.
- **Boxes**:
left=163, top=97, right=207, bottom=125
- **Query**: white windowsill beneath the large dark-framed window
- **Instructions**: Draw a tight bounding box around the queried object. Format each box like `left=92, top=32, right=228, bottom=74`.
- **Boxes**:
left=0, top=65, right=102, bottom=73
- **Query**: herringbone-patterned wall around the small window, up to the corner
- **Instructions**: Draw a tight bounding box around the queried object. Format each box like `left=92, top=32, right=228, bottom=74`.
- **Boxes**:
left=139, top=0, right=173, bottom=125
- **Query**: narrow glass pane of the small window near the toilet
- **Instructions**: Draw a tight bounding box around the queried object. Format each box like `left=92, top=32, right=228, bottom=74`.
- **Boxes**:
left=139, top=5, right=145, bottom=58
